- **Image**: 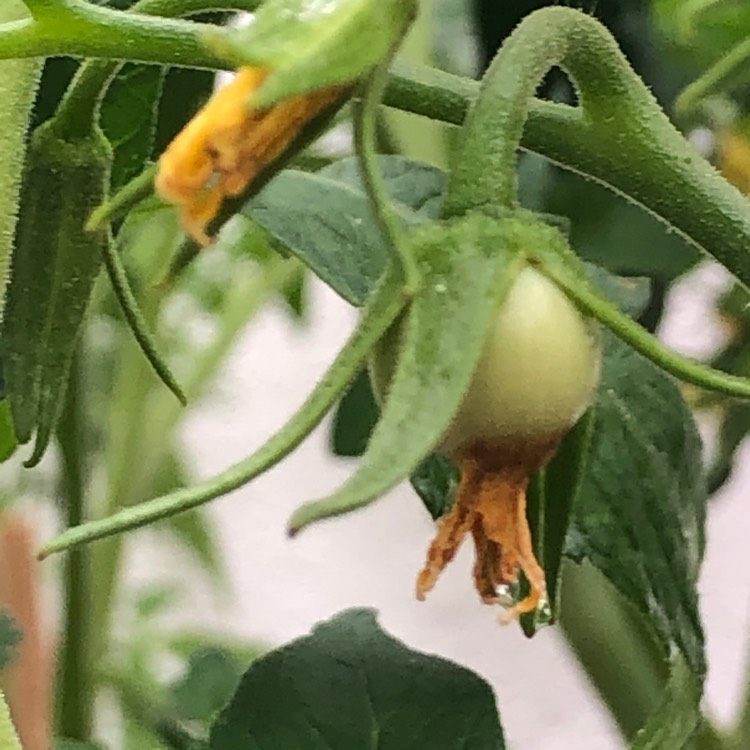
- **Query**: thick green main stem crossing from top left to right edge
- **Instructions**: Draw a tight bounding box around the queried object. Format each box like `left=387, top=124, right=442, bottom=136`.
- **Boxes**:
left=10, top=8, right=750, bottom=288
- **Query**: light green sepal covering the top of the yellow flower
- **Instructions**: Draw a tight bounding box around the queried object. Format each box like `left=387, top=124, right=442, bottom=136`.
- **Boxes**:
left=212, top=0, right=416, bottom=107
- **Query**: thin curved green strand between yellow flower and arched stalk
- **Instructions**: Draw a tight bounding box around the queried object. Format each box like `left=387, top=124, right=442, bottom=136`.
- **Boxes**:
left=354, top=51, right=420, bottom=296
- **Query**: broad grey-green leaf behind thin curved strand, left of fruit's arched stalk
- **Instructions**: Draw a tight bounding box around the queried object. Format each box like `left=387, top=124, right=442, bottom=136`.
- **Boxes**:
left=242, top=156, right=445, bottom=306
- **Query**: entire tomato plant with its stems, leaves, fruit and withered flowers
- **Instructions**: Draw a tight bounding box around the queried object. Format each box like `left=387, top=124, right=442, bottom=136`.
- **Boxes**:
left=0, top=0, right=750, bottom=750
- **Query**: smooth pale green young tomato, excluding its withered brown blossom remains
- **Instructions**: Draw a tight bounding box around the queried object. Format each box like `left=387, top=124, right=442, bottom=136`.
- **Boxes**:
left=370, top=266, right=601, bottom=462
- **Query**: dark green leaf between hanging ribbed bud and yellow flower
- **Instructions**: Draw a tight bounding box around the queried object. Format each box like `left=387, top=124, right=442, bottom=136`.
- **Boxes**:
left=100, top=63, right=165, bottom=190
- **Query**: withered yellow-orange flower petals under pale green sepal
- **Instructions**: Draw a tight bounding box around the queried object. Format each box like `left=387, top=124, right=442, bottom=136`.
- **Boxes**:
left=156, top=67, right=342, bottom=245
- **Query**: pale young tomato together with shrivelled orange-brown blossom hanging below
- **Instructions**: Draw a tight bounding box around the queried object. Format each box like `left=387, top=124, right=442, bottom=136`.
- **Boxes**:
left=371, top=265, right=601, bottom=618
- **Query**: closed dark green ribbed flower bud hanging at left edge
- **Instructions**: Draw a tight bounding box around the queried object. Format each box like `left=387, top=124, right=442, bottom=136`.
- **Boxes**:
left=2, top=119, right=112, bottom=466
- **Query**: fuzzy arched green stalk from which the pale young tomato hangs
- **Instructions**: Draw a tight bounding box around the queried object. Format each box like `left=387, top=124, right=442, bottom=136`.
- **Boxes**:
left=444, top=7, right=688, bottom=216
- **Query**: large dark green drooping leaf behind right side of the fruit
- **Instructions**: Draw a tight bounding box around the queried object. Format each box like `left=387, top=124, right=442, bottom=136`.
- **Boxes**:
left=565, top=334, right=707, bottom=750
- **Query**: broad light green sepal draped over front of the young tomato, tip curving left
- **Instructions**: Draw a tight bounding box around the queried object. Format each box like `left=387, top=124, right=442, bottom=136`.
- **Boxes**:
left=290, top=214, right=528, bottom=532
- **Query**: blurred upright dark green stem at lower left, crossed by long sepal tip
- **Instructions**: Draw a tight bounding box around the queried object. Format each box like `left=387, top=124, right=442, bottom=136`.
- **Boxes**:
left=57, top=352, right=94, bottom=742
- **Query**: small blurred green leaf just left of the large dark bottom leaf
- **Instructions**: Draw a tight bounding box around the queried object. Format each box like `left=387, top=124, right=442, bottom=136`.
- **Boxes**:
left=171, top=646, right=245, bottom=723
